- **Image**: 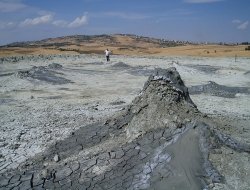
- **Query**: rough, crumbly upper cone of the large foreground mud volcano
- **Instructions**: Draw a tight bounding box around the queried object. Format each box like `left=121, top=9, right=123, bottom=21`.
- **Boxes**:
left=127, top=68, right=198, bottom=140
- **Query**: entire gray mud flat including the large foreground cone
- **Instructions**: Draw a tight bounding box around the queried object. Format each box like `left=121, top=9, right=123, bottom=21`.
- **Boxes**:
left=0, top=55, right=250, bottom=189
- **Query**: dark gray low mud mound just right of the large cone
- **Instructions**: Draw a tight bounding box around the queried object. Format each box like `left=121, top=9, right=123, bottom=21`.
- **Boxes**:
left=189, top=81, right=249, bottom=98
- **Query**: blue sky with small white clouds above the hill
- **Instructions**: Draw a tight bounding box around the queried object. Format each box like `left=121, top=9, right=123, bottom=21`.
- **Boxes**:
left=0, top=0, right=250, bottom=45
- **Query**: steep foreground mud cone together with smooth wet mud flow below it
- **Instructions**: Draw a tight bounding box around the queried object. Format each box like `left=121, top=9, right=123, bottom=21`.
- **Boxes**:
left=119, top=68, right=209, bottom=189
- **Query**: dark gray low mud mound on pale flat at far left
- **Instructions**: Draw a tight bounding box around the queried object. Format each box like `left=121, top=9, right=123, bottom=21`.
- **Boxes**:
left=17, top=64, right=71, bottom=85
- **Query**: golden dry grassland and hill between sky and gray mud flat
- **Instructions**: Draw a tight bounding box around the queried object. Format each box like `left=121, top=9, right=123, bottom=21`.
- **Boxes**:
left=0, top=35, right=250, bottom=57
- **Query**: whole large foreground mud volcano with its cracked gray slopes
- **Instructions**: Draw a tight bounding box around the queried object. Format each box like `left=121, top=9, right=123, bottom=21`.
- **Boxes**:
left=0, top=68, right=249, bottom=190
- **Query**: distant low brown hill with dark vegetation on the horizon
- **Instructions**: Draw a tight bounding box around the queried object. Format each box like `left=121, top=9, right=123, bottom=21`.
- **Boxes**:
left=3, top=34, right=188, bottom=48
